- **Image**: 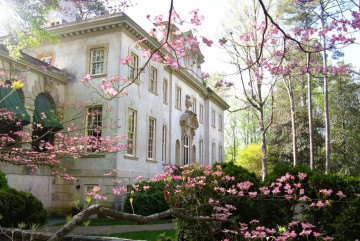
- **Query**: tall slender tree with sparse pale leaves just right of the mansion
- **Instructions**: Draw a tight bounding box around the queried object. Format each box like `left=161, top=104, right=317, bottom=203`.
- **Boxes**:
left=219, top=0, right=278, bottom=179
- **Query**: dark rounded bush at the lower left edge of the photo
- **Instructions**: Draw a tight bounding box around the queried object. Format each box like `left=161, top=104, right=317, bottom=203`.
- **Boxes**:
left=0, top=188, right=46, bottom=227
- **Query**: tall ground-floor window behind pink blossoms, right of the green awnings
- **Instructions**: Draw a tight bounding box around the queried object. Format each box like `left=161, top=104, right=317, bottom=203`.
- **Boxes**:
left=86, top=106, right=102, bottom=152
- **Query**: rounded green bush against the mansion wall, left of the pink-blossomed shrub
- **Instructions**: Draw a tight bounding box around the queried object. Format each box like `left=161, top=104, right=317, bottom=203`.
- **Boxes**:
left=124, top=182, right=169, bottom=216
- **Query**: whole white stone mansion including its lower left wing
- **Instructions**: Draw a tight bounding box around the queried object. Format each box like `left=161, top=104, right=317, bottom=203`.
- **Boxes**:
left=0, top=13, right=229, bottom=215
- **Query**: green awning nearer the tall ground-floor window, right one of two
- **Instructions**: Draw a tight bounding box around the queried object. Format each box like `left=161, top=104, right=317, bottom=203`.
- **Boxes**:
left=34, top=94, right=64, bottom=132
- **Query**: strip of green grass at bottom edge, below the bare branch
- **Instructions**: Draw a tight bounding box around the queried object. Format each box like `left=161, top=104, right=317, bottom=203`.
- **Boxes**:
left=94, top=230, right=176, bottom=241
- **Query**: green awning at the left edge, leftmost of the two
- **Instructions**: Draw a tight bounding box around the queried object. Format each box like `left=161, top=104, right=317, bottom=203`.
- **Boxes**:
left=0, top=87, right=30, bottom=125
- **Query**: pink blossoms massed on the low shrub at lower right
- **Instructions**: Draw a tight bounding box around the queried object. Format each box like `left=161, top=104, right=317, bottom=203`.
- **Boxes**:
left=146, top=164, right=346, bottom=241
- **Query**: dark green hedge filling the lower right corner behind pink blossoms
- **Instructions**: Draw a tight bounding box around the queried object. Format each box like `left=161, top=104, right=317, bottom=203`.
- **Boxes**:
left=266, top=165, right=360, bottom=241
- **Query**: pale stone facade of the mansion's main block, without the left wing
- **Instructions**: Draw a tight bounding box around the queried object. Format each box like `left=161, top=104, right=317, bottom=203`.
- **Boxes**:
left=0, top=13, right=229, bottom=214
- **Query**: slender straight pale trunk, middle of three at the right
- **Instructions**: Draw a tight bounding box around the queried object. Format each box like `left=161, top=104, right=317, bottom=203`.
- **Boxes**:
left=306, top=53, right=315, bottom=170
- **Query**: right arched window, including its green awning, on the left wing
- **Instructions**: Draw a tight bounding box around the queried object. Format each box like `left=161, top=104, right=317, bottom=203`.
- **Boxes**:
left=32, top=93, right=63, bottom=151
